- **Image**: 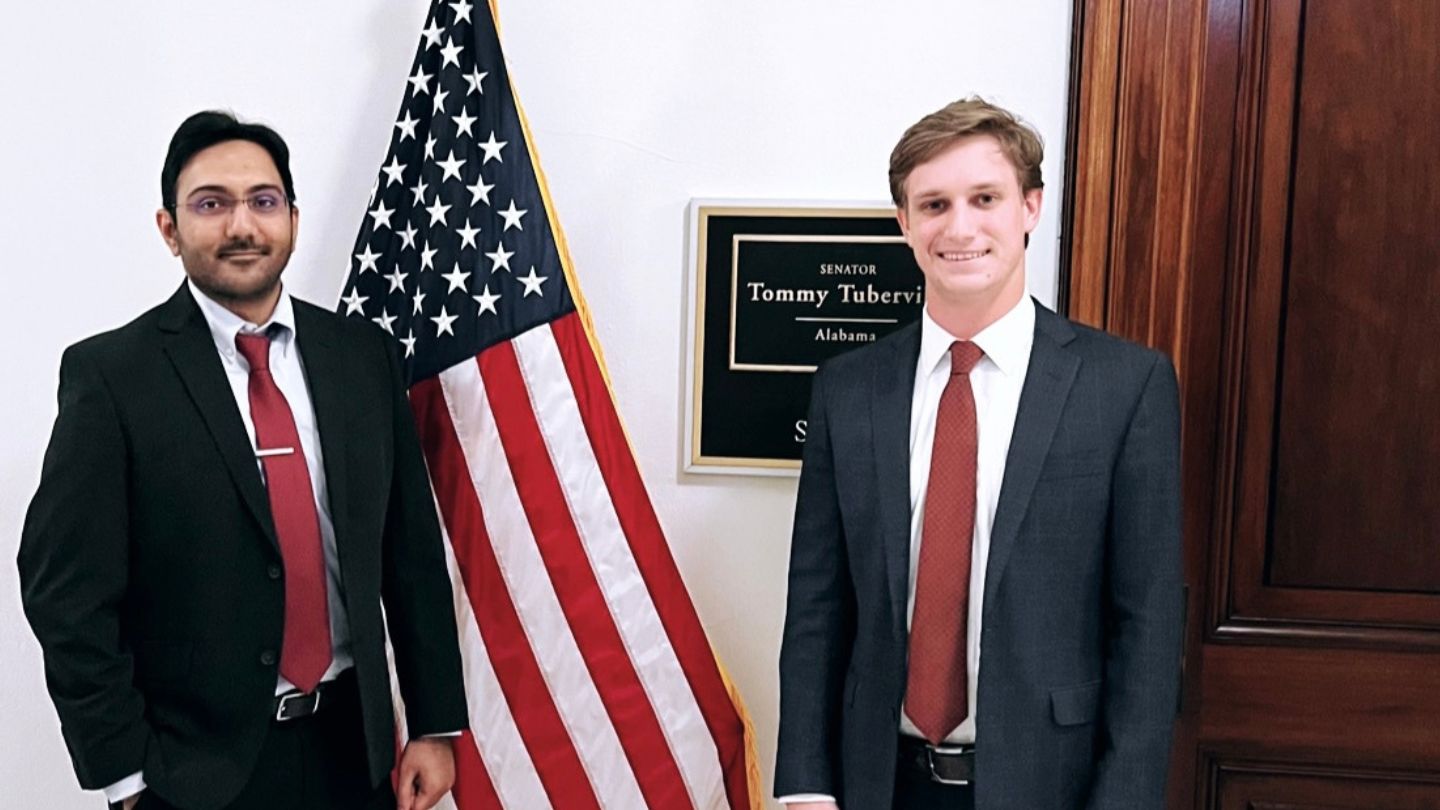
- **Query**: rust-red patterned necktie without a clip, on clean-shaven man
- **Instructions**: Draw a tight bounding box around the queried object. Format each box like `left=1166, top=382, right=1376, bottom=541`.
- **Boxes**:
left=904, top=340, right=985, bottom=744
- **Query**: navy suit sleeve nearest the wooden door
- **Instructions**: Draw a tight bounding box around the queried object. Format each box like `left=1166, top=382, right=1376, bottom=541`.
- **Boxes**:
left=1087, top=355, right=1184, bottom=810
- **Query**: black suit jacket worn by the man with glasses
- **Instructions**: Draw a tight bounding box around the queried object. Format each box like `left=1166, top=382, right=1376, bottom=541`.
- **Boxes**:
left=19, top=285, right=467, bottom=809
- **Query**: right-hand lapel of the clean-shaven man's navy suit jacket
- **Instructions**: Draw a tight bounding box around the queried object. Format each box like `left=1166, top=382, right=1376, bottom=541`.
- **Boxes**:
left=985, top=304, right=1080, bottom=605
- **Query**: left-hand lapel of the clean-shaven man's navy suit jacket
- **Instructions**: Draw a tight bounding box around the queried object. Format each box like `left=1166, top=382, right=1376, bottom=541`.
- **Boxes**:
left=870, top=323, right=920, bottom=638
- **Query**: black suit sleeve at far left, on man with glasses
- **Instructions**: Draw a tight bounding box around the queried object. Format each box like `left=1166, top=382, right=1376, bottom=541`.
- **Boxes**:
left=17, top=347, right=150, bottom=790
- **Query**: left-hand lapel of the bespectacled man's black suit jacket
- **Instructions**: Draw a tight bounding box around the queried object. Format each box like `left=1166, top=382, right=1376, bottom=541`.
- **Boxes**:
left=160, top=284, right=279, bottom=551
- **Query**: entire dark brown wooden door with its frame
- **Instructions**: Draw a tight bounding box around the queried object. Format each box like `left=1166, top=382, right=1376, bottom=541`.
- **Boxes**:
left=1063, top=0, right=1440, bottom=810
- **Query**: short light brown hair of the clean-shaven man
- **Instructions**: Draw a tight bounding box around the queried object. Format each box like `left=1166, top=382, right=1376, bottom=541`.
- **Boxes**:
left=890, top=97, right=1044, bottom=206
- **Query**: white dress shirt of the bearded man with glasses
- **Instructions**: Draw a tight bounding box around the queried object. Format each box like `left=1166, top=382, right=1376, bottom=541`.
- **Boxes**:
left=105, top=281, right=354, bottom=801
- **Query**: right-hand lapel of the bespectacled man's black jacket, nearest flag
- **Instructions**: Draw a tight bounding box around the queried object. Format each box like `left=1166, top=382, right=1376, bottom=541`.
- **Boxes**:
left=291, top=298, right=350, bottom=561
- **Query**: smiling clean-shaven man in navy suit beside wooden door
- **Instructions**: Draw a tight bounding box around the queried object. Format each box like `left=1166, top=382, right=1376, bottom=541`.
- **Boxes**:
left=775, top=99, right=1182, bottom=810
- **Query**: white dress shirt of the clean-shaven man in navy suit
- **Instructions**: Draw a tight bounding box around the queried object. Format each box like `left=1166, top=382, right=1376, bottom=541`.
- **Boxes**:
left=780, top=295, right=1035, bottom=804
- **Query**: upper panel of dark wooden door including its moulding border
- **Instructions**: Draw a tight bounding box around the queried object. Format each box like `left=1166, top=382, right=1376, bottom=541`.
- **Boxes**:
left=1214, top=0, right=1440, bottom=649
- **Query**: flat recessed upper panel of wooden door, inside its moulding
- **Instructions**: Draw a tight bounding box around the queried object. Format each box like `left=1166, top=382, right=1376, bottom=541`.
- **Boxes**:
left=1269, top=0, right=1440, bottom=594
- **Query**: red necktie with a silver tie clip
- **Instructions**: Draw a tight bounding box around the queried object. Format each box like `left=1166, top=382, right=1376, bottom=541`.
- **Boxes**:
left=235, top=334, right=331, bottom=692
